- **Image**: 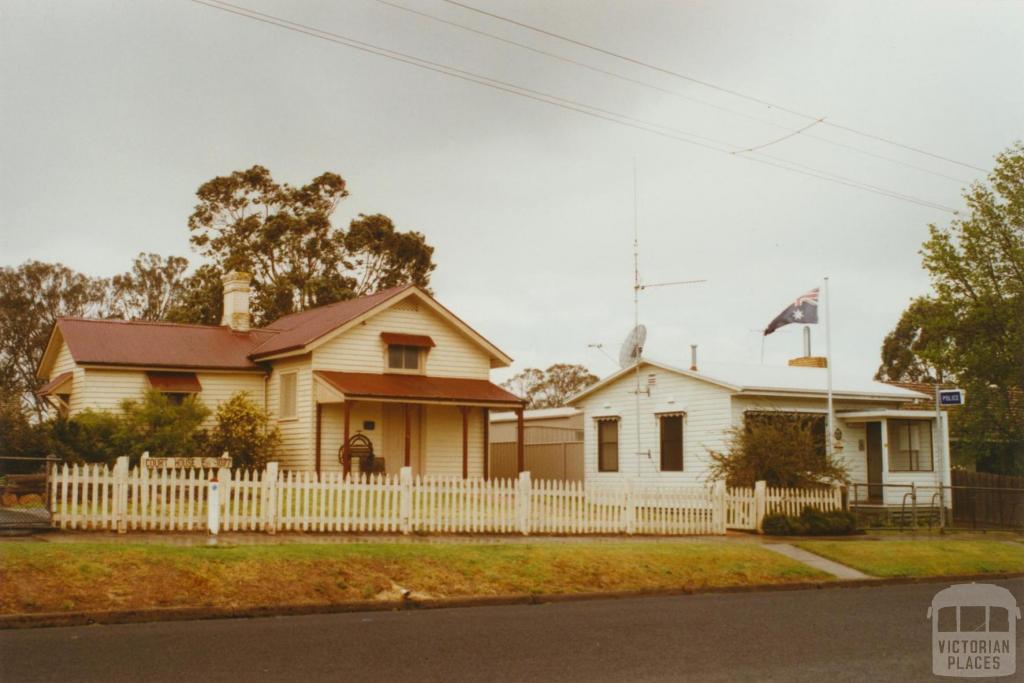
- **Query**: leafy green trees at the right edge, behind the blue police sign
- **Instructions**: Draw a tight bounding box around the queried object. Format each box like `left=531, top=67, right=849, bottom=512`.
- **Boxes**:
left=877, top=142, right=1024, bottom=473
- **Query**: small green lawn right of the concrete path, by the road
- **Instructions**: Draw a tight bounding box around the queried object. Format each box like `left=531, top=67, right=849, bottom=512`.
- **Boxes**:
left=796, top=539, right=1024, bottom=577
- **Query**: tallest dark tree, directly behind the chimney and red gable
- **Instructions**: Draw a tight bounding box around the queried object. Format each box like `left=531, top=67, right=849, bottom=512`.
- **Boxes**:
left=188, top=166, right=434, bottom=324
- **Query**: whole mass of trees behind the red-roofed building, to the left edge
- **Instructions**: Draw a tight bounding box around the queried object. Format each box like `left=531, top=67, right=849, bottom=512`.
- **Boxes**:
left=0, top=166, right=435, bottom=417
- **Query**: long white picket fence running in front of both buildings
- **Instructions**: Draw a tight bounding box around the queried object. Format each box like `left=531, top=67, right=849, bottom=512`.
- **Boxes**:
left=49, top=458, right=839, bottom=536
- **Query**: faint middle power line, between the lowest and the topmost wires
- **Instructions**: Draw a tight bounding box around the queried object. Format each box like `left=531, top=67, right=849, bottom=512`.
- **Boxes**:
left=376, top=0, right=971, bottom=185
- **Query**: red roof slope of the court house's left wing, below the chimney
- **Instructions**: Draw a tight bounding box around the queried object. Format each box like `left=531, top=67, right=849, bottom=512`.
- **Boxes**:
left=57, top=317, right=267, bottom=370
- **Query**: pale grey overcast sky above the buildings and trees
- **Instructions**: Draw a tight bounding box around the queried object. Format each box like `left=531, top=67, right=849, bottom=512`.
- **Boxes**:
left=0, top=0, right=1024, bottom=380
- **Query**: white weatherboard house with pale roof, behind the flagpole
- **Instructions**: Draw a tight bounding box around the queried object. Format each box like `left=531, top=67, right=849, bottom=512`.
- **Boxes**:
left=570, top=357, right=949, bottom=505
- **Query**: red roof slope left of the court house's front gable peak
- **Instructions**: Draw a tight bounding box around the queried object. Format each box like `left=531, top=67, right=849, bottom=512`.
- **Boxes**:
left=252, top=285, right=413, bottom=358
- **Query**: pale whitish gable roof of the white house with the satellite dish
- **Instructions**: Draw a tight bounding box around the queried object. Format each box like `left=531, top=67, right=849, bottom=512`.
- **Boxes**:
left=569, top=358, right=928, bottom=404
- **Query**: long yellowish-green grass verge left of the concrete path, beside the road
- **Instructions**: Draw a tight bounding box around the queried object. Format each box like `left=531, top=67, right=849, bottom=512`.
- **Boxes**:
left=0, top=542, right=830, bottom=614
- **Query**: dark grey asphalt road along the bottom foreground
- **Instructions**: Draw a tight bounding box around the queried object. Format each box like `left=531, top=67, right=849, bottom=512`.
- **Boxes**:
left=0, top=580, right=1024, bottom=683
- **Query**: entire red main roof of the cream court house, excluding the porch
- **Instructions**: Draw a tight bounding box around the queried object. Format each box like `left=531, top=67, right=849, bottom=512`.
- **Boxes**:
left=37, top=285, right=512, bottom=376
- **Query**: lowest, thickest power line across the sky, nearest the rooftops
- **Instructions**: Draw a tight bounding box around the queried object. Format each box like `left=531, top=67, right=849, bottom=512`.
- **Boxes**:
left=191, top=0, right=955, bottom=213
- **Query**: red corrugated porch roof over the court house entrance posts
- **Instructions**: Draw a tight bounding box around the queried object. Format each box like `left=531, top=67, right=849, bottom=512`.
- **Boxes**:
left=314, top=370, right=523, bottom=408
